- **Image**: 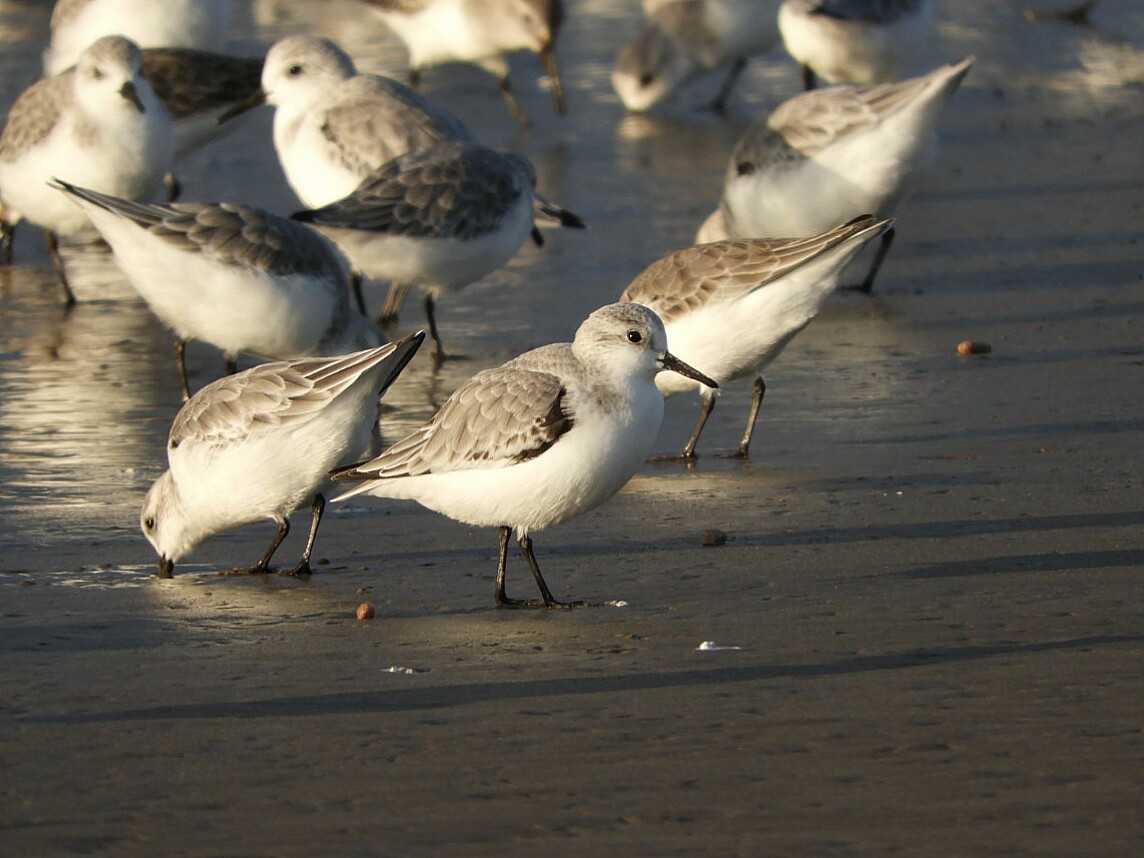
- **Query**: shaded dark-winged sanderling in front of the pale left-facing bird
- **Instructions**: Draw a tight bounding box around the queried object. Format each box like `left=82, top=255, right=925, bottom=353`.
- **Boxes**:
left=293, top=141, right=583, bottom=363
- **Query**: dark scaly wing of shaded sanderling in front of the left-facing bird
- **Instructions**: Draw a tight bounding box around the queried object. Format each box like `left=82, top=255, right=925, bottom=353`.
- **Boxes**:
left=292, top=143, right=533, bottom=240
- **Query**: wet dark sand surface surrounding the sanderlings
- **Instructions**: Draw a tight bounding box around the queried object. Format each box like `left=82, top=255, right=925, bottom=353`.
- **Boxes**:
left=0, top=0, right=1144, bottom=856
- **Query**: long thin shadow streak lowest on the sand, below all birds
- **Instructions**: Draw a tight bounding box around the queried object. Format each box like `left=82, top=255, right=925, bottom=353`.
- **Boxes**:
left=29, top=635, right=1144, bottom=724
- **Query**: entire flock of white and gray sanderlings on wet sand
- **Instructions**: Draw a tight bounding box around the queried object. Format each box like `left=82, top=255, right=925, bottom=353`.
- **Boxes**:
left=0, top=0, right=974, bottom=607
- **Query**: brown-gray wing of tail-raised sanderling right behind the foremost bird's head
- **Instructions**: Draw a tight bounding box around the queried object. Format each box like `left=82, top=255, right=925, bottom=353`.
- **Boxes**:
left=620, top=215, right=877, bottom=324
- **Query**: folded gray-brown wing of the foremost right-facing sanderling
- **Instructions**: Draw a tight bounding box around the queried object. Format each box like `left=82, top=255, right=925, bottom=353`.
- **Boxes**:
left=334, top=366, right=573, bottom=480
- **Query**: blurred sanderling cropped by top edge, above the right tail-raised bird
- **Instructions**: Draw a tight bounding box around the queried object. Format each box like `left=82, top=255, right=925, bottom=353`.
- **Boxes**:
left=778, top=0, right=934, bottom=89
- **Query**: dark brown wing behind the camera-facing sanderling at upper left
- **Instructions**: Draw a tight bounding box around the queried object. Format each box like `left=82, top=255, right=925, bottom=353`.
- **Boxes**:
left=143, top=48, right=262, bottom=119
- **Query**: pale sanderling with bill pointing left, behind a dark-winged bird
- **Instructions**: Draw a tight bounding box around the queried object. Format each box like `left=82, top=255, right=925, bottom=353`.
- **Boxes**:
left=223, top=35, right=469, bottom=208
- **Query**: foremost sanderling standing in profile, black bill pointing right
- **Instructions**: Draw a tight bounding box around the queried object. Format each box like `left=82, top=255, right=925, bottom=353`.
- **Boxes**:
left=333, top=304, right=716, bottom=607
